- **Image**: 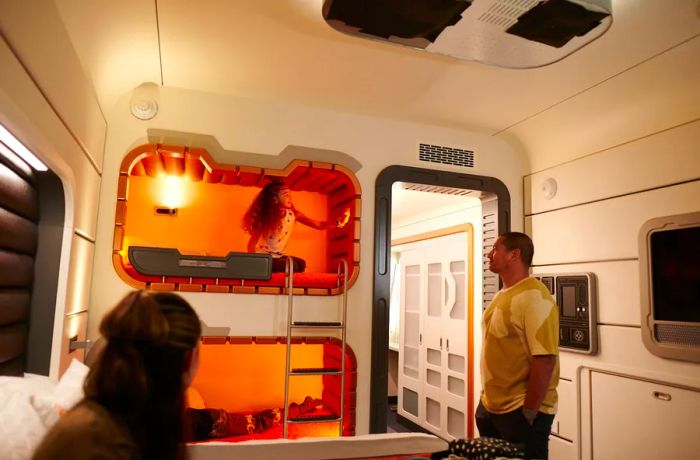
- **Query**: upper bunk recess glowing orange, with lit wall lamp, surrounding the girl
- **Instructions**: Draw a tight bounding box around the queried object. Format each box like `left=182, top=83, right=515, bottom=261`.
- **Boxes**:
left=112, top=144, right=361, bottom=295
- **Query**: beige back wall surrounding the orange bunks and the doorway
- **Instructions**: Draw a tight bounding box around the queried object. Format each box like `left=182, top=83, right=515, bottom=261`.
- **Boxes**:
left=89, top=88, right=527, bottom=433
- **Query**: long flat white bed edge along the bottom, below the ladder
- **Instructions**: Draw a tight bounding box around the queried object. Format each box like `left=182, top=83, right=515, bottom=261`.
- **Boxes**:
left=187, top=433, right=447, bottom=460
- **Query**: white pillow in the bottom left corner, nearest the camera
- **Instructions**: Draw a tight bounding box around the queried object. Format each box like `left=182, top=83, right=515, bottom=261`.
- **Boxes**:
left=0, top=376, right=56, bottom=460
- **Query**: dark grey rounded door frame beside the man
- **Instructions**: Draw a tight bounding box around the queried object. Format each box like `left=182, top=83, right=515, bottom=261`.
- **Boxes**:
left=369, top=165, right=510, bottom=433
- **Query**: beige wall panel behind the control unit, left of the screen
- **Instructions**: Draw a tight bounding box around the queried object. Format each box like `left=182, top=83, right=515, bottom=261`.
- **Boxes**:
left=532, top=260, right=640, bottom=326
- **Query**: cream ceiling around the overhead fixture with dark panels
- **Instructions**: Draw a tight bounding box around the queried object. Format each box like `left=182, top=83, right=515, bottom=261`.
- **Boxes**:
left=55, top=0, right=700, bottom=168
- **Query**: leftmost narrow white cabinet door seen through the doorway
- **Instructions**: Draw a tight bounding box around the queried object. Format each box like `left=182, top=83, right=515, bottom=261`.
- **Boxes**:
left=397, top=249, right=425, bottom=424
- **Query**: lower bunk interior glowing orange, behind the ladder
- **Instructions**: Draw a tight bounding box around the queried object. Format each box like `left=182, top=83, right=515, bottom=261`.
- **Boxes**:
left=188, top=337, right=357, bottom=442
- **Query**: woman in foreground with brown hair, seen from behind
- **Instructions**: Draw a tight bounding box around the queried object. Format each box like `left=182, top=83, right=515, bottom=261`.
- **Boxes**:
left=33, top=291, right=201, bottom=460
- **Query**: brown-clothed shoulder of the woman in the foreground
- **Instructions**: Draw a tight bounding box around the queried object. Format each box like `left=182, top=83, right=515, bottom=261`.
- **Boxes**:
left=33, top=401, right=137, bottom=460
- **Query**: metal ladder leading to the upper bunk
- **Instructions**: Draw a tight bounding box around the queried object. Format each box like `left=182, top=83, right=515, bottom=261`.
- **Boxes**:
left=283, top=257, right=348, bottom=439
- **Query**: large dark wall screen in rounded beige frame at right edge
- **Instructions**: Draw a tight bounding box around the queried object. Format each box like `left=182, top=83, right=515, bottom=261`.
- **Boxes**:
left=639, top=212, right=700, bottom=362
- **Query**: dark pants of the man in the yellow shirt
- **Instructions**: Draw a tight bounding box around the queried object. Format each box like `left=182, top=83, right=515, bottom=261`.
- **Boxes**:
left=475, top=402, right=554, bottom=459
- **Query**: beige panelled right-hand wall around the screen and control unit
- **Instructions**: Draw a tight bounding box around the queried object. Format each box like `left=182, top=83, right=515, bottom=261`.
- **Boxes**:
left=524, top=121, right=700, bottom=458
